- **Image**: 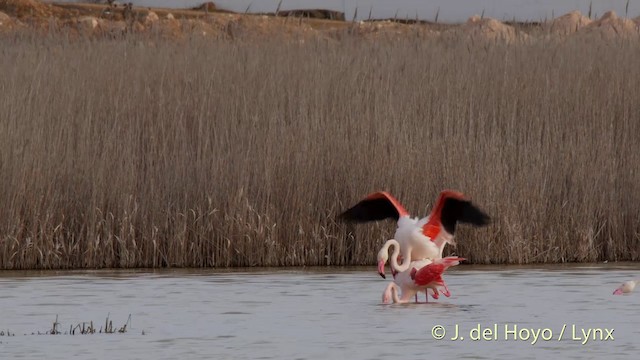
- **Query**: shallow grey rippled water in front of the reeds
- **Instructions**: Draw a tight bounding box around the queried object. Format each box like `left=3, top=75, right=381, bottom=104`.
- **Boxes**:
left=0, top=264, right=640, bottom=360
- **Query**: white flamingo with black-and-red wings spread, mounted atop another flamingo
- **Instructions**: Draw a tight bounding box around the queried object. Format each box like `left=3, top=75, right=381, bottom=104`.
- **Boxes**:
left=339, top=190, right=490, bottom=278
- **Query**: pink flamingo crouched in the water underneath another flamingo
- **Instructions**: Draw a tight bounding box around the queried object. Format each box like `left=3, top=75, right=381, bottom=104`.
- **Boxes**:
left=382, top=257, right=464, bottom=304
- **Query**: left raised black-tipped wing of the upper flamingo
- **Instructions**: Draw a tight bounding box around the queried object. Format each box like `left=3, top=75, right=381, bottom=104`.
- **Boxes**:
left=339, top=191, right=409, bottom=222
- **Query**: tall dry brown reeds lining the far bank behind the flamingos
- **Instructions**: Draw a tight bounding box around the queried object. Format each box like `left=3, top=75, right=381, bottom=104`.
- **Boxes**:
left=0, top=31, right=640, bottom=269
